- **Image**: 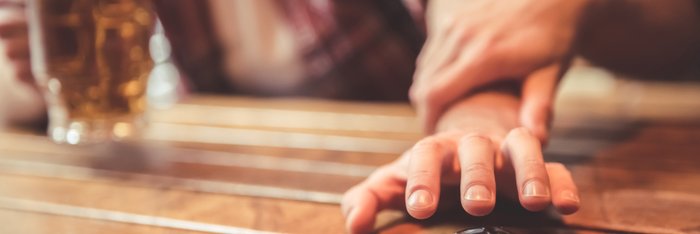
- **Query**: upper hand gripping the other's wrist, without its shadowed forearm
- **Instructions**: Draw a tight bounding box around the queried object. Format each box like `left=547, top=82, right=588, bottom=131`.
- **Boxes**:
left=411, top=0, right=590, bottom=140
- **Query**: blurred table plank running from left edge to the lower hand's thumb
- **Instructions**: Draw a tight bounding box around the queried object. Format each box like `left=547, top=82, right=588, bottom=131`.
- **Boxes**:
left=0, top=139, right=375, bottom=194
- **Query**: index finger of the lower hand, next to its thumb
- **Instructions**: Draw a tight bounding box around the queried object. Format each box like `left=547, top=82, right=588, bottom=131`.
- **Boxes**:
left=405, top=137, right=445, bottom=219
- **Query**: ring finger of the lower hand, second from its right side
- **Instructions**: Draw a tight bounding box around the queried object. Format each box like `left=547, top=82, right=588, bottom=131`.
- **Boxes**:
left=502, top=127, right=551, bottom=211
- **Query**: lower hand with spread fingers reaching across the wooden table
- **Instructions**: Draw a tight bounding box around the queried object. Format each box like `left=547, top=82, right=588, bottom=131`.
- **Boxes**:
left=342, top=92, right=579, bottom=233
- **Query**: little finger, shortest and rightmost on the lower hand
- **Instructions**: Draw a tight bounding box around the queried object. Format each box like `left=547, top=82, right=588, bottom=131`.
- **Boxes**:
left=546, top=163, right=581, bottom=214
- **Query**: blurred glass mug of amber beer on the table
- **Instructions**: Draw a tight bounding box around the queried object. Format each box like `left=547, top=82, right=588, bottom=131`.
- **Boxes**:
left=27, top=0, right=156, bottom=144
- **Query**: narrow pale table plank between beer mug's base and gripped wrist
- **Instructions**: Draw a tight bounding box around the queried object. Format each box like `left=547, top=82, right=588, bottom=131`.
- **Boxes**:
left=150, top=104, right=420, bottom=136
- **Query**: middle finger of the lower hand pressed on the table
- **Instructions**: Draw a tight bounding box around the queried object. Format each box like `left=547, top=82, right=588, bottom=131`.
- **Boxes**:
left=458, top=135, right=496, bottom=216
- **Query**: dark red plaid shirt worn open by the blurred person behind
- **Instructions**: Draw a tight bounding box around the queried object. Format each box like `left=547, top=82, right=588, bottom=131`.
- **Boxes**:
left=156, top=0, right=424, bottom=100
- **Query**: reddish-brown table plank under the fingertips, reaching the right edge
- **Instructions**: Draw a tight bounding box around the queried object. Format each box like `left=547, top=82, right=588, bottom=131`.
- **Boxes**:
left=378, top=165, right=700, bottom=233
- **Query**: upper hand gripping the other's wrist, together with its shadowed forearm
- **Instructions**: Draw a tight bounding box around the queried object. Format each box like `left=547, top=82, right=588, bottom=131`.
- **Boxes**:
left=410, top=0, right=700, bottom=140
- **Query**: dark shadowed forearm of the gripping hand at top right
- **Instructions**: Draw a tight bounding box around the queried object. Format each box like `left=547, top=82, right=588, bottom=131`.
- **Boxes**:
left=578, top=0, right=700, bottom=77
